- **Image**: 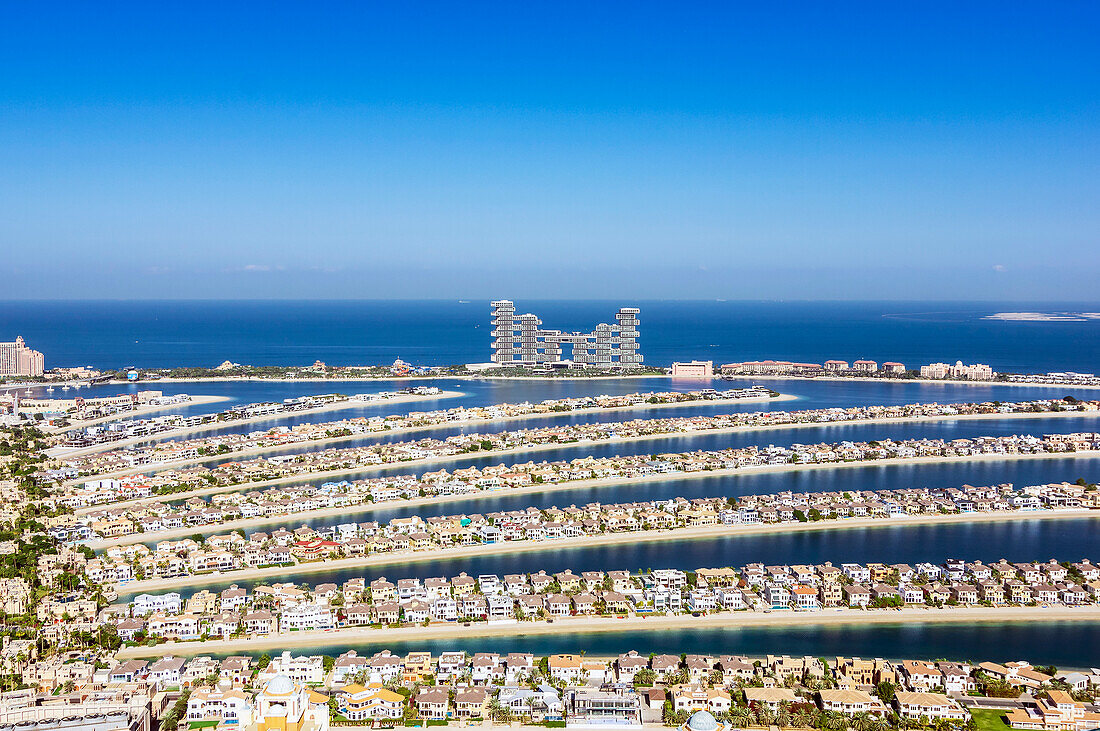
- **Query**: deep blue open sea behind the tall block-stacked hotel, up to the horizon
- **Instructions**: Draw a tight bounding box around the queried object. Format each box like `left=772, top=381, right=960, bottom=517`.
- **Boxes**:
left=0, top=292, right=1100, bottom=372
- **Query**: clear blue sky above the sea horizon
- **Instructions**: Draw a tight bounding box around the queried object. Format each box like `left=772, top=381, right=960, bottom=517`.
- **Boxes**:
left=0, top=2, right=1100, bottom=300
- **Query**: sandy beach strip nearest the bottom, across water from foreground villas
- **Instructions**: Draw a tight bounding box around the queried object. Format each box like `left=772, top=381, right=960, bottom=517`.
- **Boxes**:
left=118, top=606, right=1100, bottom=660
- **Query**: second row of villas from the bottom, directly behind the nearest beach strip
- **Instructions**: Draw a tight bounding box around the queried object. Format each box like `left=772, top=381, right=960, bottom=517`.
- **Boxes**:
left=90, top=560, right=1100, bottom=641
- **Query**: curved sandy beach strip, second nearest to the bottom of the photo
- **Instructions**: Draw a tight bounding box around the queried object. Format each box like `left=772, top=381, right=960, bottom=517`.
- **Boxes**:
left=119, top=509, right=1100, bottom=595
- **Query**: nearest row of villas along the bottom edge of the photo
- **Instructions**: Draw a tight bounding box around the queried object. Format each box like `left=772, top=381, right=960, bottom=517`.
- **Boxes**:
left=17, top=650, right=1100, bottom=731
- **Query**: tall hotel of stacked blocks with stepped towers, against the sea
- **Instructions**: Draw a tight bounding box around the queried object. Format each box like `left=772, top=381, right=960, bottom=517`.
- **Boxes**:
left=492, top=299, right=641, bottom=368
